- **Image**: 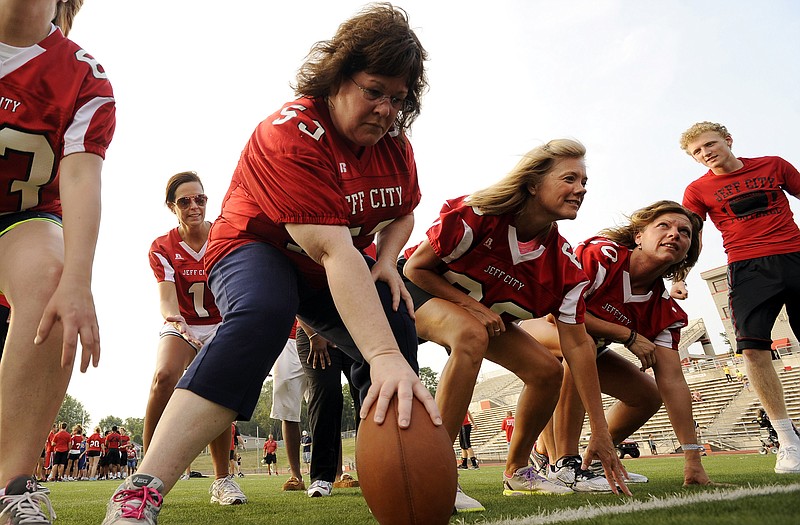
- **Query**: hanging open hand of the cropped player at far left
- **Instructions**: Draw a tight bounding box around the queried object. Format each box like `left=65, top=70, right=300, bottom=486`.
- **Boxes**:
left=33, top=276, right=100, bottom=372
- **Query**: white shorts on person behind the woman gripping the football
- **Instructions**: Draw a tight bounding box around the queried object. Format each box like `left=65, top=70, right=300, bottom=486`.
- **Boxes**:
left=269, top=339, right=308, bottom=422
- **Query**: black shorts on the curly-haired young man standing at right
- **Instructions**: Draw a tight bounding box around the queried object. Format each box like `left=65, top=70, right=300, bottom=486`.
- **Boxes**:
left=728, top=252, right=800, bottom=354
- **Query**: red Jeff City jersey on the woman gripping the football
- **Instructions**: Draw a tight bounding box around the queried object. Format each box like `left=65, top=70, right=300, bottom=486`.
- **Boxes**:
left=206, top=98, right=420, bottom=286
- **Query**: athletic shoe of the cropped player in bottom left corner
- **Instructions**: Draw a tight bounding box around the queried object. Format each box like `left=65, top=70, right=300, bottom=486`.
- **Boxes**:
left=0, top=476, right=56, bottom=525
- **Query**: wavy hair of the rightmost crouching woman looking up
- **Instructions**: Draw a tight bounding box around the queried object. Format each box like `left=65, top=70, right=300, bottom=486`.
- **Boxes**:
left=600, top=200, right=703, bottom=281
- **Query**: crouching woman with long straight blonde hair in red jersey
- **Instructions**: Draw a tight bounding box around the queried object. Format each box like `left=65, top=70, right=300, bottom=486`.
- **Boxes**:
left=399, top=139, right=628, bottom=502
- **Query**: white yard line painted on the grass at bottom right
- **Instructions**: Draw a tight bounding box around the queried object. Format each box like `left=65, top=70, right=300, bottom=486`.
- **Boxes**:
left=466, top=483, right=800, bottom=525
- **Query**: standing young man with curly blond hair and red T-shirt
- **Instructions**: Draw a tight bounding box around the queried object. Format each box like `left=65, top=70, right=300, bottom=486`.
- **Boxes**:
left=676, top=122, right=800, bottom=474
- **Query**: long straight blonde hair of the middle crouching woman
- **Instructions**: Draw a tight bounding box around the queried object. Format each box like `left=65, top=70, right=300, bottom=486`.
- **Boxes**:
left=469, top=139, right=586, bottom=215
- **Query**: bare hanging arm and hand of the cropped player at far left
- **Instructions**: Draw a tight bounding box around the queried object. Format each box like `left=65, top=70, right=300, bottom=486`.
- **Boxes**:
left=34, top=153, right=103, bottom=372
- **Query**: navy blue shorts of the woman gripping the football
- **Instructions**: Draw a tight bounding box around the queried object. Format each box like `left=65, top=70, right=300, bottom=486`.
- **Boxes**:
left=176, top=242, right=419, bottom=421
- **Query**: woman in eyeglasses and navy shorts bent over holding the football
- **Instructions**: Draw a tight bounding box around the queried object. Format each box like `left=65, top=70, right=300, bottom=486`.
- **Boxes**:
left=105, top=4, right=440, bottom=524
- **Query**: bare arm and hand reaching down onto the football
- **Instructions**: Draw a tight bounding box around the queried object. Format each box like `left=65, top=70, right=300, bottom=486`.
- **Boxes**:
left=286, top=224, right=442, bottom=428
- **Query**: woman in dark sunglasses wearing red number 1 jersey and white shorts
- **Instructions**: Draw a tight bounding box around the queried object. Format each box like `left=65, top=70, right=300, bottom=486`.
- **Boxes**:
left=142, top=171, right=247, bottom=505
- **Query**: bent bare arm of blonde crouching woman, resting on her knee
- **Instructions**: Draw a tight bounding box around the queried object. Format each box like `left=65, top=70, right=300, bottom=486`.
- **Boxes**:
left=403, top=240, right=505, bottom=337
